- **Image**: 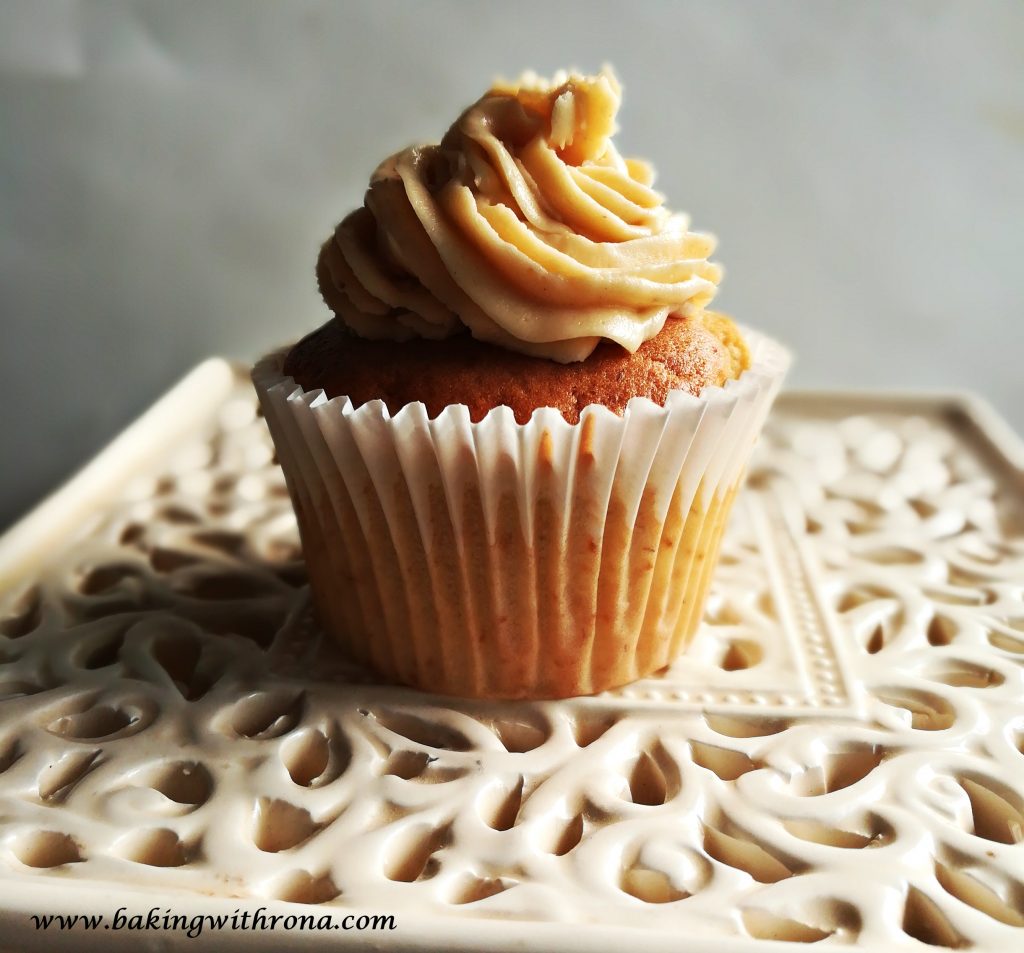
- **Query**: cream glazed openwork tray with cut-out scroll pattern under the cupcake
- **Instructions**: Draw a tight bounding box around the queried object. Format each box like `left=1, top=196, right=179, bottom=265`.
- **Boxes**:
left=0, top=361, right=1024, bottom=953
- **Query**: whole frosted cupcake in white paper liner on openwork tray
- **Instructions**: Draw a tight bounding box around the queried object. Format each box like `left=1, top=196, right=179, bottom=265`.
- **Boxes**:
left=253, top=65, right=787, bottom=698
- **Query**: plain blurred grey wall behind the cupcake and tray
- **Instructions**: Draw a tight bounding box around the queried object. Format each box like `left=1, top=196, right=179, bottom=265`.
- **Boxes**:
left=0, top=0, right=1024, bottom=525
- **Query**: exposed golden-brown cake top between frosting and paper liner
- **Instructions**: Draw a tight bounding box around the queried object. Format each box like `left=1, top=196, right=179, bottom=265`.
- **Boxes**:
left=285, top=312, right=749, bottom=424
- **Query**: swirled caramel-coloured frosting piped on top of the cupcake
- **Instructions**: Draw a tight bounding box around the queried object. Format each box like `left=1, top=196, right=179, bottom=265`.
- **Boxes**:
left=316, top=70, right=721, bottom=362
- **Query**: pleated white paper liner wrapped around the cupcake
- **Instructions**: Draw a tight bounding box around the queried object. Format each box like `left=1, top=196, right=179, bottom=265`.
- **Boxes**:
left=253, top=332, right=788, bottom=698
